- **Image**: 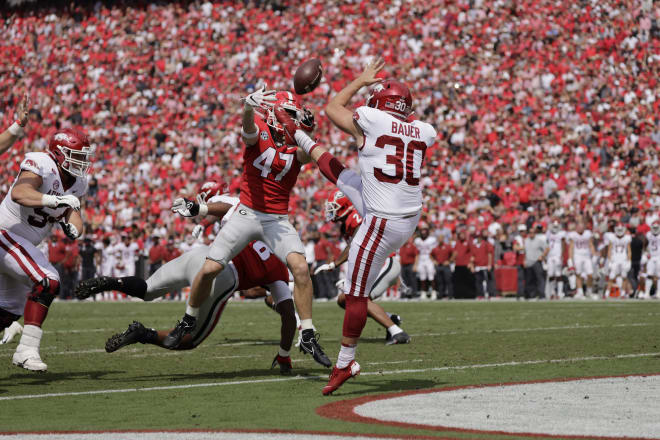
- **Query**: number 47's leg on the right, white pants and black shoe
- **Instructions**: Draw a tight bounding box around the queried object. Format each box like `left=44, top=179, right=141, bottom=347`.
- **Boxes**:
left=260, top=214, right=332, bottom=367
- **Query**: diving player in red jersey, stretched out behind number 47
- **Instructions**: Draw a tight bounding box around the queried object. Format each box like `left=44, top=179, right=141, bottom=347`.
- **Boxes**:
left=75, top=195, right=296, bottom=374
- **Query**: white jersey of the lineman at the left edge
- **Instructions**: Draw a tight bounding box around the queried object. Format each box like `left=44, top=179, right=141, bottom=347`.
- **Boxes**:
left=0, top=153, right=87, bottom=246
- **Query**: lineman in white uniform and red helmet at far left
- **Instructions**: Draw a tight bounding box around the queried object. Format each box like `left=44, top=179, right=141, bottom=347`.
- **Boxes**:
left=0, top=128, right=94, bottom=371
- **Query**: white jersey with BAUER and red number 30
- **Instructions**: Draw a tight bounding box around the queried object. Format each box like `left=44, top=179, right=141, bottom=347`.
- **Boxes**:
left=353, top=106, right=437, bottom=218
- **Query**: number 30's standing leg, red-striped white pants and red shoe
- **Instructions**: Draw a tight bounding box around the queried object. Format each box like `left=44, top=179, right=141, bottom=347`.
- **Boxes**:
left=322, top=214, right=419, bottom=395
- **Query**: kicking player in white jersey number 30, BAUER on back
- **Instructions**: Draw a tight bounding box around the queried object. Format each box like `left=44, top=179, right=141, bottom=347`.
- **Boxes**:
left=296, top=59, right=436, bottom=395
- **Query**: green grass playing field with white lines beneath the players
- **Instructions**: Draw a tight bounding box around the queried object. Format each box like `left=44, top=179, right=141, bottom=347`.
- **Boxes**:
left=0, top=301, right=660, bottom=438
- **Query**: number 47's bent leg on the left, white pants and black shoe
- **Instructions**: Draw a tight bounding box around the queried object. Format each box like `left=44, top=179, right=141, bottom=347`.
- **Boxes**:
left=163, top=211, right=263, bottom=349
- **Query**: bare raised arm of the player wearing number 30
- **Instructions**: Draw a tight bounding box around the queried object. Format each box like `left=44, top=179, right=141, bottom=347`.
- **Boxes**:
left=325, top=57, right=385, bottom=145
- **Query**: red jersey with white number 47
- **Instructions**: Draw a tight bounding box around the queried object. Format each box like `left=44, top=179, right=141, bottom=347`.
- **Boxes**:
left=240, top=118, right=301, bottom=214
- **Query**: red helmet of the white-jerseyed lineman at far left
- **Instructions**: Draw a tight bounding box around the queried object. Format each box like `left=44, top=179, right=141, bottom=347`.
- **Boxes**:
left=48, top=128, right=95, bottom=177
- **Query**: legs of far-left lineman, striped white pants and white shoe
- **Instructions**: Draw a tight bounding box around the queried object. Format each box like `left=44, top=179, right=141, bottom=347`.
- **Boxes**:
left=0, top=230, right=60, bottom=371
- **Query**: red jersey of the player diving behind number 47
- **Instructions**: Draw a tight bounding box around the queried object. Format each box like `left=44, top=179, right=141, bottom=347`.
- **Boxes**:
left=231, top=241, right=289, bottom=290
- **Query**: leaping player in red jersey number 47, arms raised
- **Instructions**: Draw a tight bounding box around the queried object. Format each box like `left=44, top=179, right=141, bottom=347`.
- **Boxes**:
left=163, top=87, right=332, bottom=367
